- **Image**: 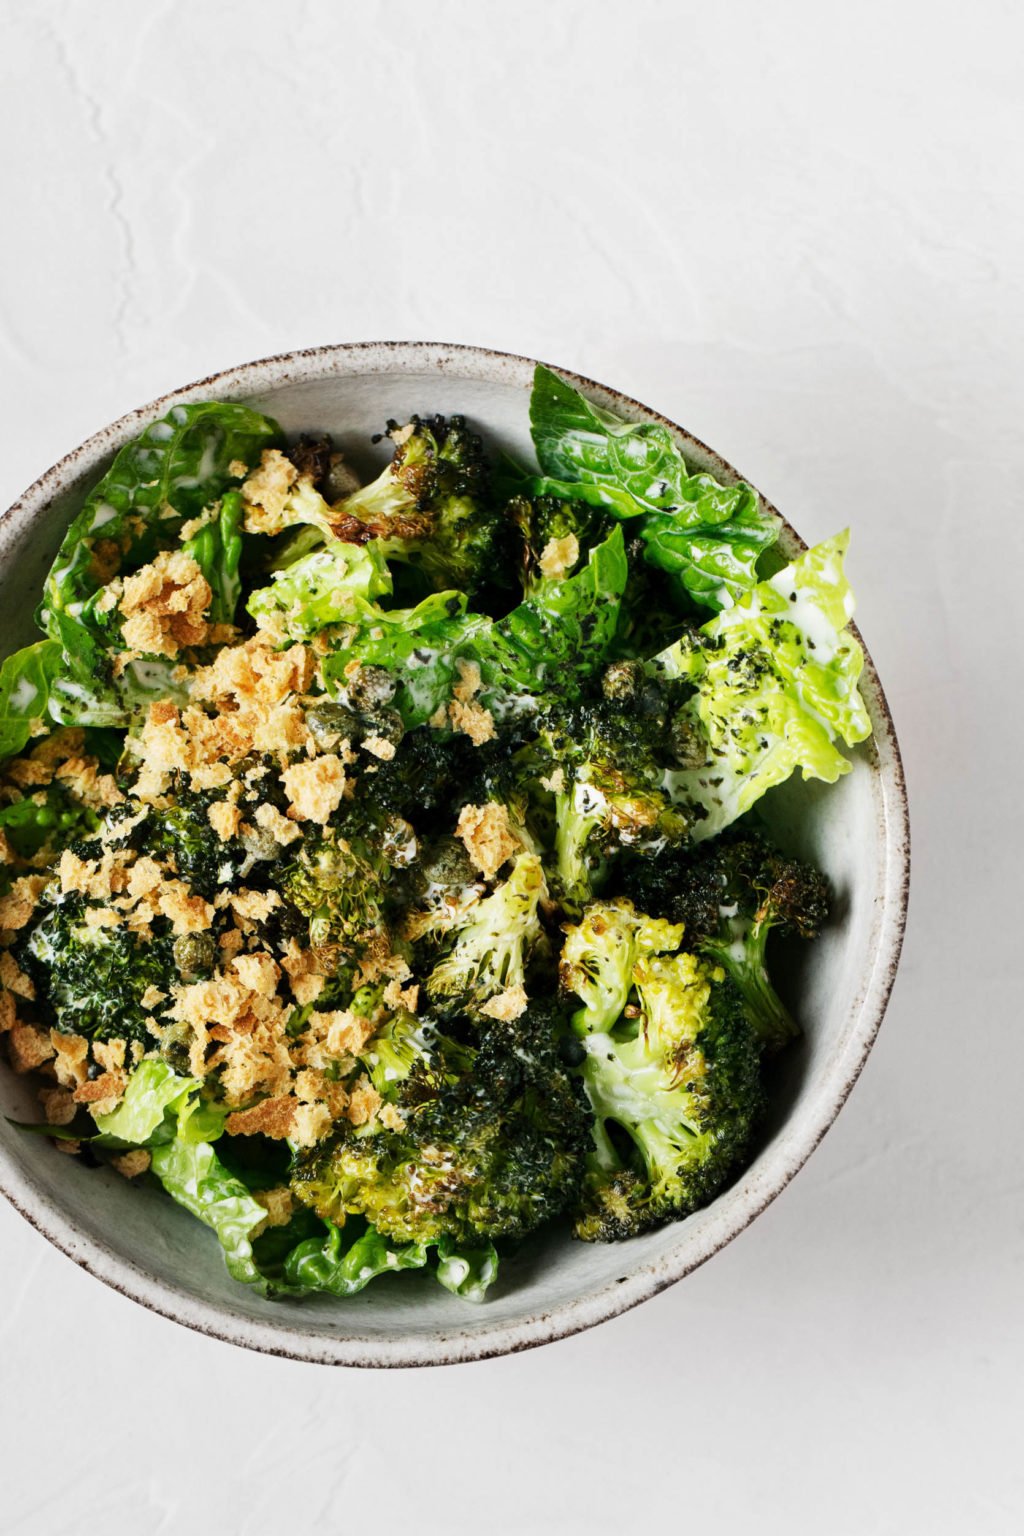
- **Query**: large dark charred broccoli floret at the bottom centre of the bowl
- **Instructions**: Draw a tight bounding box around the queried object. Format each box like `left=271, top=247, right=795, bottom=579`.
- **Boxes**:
left=292, top=1008, right=590, bottom=1243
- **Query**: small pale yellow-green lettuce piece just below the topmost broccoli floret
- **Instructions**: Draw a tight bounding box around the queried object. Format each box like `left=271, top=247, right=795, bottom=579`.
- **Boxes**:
left=246, top=541, right=396, bottom=641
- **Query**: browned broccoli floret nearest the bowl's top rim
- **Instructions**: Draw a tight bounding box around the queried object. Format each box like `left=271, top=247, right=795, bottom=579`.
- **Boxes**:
left=332, top=416, right=508, bottom=594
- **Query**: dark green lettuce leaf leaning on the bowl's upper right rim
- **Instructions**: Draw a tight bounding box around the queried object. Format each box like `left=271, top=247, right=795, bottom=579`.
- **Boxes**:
left=530, top=367, right=778, bottom=608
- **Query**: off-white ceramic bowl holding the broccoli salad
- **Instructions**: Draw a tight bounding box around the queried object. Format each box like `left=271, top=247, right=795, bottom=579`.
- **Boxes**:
left=0, top=343, right=909, bottom=1366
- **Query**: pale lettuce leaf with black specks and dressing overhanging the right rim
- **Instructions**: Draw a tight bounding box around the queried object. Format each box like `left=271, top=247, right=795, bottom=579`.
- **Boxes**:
left=652, top=533, right=870, bottom=842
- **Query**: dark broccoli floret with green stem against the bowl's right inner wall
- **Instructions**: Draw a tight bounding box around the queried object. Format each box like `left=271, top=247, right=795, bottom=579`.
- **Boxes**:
left=623, top=833, right=829, bottom=1051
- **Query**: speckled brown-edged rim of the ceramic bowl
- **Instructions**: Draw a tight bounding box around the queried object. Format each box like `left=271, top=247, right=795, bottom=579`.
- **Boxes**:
left=0, top=341, right=910, bottom=1367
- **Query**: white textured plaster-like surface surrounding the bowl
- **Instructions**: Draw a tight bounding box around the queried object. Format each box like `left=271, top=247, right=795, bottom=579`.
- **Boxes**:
left=0, top=0, right=1024, bottom=1536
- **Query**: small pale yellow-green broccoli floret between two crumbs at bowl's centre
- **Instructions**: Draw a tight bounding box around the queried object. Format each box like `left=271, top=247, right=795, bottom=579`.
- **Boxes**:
left=427, top=852, right=547, bottom=1012
